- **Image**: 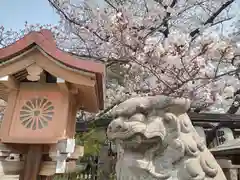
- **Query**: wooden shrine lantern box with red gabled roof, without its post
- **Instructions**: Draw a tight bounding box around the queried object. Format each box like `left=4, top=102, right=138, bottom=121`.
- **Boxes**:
left=0, top=30, right=105, bottom=144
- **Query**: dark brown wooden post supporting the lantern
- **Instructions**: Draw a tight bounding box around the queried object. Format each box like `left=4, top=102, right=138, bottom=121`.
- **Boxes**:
left=20, top=145, right=43, bottom=180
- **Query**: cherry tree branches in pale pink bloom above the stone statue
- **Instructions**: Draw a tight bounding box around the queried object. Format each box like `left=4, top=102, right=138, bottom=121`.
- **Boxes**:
left=46, top=0, right=240, bottom=112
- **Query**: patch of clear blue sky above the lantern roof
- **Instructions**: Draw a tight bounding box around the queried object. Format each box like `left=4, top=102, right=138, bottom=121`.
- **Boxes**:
left=0, top=0, right=59, bottom=30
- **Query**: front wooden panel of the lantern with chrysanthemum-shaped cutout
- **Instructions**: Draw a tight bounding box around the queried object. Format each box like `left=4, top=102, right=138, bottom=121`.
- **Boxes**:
left=3, top=83, right=68, bottom=144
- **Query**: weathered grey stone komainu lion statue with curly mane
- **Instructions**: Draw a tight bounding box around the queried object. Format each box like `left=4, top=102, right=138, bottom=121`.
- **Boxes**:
left=107, top=96, right=226, bottom=180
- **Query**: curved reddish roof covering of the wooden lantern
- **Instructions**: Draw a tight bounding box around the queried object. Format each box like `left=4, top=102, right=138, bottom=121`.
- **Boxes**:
left=0, top=29, right=105, bottom=109
